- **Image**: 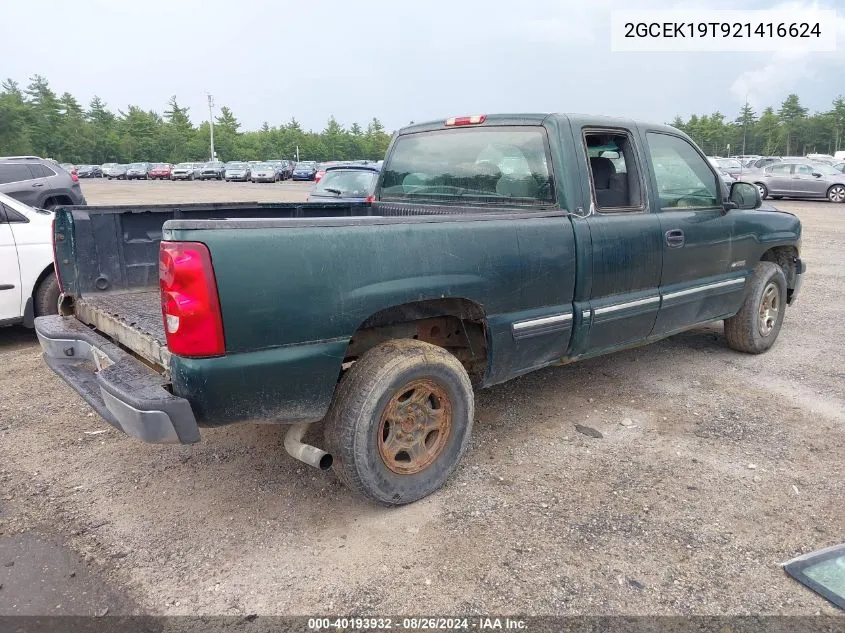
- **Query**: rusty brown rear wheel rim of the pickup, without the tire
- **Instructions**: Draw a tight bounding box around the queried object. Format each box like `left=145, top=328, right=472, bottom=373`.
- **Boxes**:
left=377, top=378, right=452, bottom=475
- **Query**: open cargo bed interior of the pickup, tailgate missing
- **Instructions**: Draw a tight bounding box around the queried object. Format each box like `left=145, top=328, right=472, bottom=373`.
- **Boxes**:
left=56, top=202, right=371, bottom=372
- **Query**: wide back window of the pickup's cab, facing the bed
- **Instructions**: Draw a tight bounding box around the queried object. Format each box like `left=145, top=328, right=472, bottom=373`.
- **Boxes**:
left=381, top=126, right=555, bottom=206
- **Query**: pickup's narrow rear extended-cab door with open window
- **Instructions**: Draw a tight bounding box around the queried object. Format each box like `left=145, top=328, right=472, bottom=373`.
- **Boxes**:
left=571, top=121, right=663, bottom=356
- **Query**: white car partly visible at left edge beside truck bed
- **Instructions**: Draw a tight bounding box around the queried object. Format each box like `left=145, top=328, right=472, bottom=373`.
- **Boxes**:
left=0, top=190, right=62, bottom=327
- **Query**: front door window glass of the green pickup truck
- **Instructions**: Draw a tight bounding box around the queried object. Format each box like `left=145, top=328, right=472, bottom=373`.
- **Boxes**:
left=646, top=132, right=720, bottom=209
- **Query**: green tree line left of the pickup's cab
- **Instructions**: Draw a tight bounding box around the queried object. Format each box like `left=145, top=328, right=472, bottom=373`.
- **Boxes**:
left=0, top=75, right=390, bottom=164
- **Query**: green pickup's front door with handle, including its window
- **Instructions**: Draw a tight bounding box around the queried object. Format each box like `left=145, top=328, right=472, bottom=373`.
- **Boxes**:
left=644, top=130, right=746, bottom=336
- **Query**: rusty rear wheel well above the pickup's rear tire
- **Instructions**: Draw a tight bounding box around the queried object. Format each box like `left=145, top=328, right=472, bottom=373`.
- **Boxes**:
left=343, top=298, right=487, bottom=384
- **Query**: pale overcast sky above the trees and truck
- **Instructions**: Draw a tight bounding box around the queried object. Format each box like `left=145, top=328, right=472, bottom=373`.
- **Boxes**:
left=0, top=0, right=845, bottom=130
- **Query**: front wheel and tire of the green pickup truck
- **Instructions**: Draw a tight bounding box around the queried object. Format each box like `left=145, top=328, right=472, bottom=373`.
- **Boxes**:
left=725, top=262, right=786, bottom=354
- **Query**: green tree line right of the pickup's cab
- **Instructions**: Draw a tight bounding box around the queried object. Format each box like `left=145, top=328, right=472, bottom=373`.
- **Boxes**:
left=670, top=94, right=845, bottom=156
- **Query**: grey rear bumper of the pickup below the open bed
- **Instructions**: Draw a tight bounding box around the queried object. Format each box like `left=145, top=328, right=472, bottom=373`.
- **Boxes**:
left=35, top=316, right=200, bottom=444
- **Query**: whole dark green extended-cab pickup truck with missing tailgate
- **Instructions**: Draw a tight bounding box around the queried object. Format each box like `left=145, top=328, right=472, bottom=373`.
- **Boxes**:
left=35, top=114, right=805, bottom=505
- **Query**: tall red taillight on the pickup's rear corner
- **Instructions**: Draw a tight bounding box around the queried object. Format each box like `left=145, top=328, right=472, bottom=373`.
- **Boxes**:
left=158, top=242, right=226, bottom=357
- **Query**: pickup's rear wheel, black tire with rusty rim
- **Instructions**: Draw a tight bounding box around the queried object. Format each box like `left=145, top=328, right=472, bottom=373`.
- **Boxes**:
left=325, top=339, right=475, bottom=506
